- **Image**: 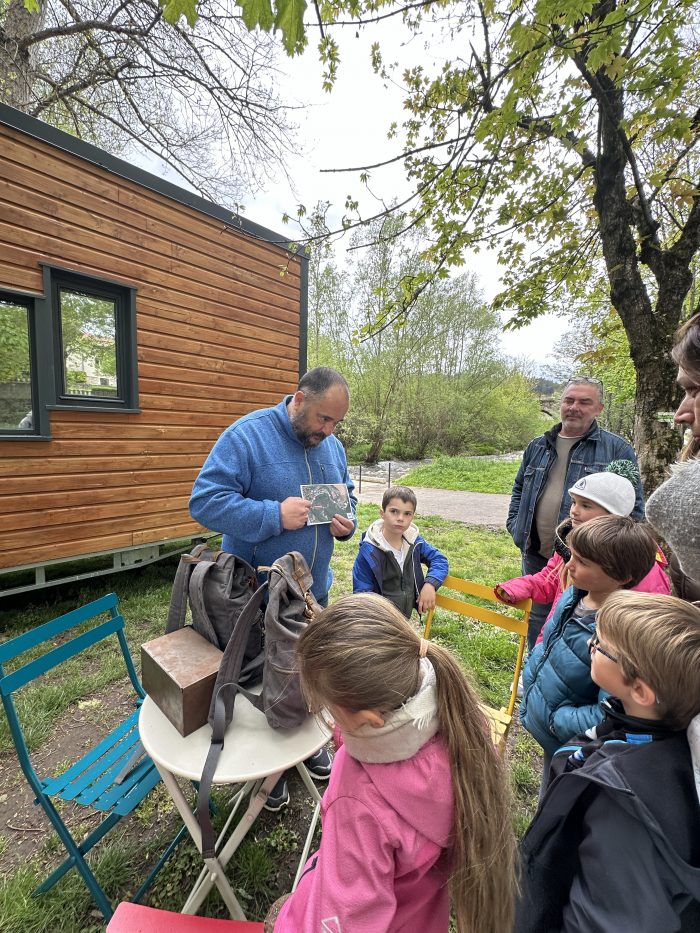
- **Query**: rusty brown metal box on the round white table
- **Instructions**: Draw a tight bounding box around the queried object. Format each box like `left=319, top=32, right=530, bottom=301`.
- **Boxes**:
left=141, top=625, right=223, bottom=736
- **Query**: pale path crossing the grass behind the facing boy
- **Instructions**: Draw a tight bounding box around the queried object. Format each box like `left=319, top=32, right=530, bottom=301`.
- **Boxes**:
left=355, top=478, right=510, bottom=528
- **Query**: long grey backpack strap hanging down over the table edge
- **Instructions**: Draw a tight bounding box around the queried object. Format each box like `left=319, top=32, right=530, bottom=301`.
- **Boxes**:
left=197, top=583, right=267, bottom=859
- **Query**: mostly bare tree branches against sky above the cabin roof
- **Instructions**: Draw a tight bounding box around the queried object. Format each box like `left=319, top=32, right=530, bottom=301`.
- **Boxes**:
left=0, top=0, right=290, bottom=203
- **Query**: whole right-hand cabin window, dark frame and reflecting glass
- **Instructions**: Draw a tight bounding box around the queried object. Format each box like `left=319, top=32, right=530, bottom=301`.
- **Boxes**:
left=47, top=269, right=138, bottom=411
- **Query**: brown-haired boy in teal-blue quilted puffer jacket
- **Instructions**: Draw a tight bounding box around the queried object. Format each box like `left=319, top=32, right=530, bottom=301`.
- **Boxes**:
left=520, top=515, right=656, bottom=788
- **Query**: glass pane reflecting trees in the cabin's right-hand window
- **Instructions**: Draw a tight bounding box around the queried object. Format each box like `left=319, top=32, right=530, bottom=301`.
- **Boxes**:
left=59, top=287, right=120, bottom=398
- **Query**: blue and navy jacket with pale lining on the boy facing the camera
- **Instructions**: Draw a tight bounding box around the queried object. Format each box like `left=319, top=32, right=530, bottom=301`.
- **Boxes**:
left=352, top=518, right=448, bottom=609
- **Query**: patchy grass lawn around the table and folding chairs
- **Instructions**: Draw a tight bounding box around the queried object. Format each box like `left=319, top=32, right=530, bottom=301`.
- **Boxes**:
left=0, top=506, right=539, bottom=933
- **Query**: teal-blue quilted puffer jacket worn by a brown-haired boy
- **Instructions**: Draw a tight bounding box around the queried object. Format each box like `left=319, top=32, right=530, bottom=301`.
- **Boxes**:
left=520, top=586, right=607, bottom=755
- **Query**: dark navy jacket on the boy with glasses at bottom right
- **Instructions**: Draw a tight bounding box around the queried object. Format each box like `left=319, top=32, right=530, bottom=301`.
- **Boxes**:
left=514, top=697, right=700, bottom=933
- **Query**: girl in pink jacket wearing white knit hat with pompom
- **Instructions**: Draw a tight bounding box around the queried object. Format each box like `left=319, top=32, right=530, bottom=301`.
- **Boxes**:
left=494, top=460, right=671, bottom=644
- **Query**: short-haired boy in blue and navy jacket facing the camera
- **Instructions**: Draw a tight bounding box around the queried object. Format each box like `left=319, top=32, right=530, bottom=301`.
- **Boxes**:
left=352, top=486, right=448, bottom=619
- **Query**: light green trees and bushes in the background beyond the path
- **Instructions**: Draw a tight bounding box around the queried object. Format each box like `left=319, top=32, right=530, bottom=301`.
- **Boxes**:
left=308, top=205, right=544, bottom=461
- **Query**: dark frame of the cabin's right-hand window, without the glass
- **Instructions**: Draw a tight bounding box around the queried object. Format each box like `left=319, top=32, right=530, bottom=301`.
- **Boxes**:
left=43, top=264, right=140, bottom=412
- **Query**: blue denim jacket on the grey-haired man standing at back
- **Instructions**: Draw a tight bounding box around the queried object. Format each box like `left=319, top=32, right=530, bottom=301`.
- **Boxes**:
left=506, top=421, right=644, bottom=551
